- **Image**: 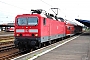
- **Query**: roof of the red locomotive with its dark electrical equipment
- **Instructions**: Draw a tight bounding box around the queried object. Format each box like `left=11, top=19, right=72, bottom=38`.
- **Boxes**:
left=17, top=9, right=64, bottom=22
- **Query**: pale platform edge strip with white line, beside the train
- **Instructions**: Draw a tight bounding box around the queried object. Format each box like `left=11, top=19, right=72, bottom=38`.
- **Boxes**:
left=11, top=36, right=79, bottom=60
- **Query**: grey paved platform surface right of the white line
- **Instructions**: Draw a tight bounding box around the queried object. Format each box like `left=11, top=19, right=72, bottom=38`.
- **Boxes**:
left=35, top=33, right=90, bottom=60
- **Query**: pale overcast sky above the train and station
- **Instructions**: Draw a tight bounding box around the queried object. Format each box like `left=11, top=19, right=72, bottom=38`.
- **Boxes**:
left=0, top=0, right=90, bottom=24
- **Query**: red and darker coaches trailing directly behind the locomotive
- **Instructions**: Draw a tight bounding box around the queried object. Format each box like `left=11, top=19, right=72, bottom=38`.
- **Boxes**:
left=66, top=21, right=82, bottom=37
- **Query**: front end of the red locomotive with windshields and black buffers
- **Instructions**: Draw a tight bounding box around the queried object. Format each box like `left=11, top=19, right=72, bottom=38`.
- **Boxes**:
left=14, top=14, right=40, bottom=50
